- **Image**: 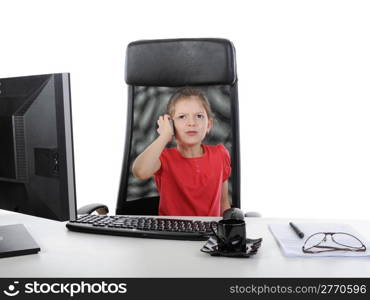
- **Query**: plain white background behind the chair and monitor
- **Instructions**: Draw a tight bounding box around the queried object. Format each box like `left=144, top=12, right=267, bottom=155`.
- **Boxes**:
left=0, top=0, right=370, bottom=219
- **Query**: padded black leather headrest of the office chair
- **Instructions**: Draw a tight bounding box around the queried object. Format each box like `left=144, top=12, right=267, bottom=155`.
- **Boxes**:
left=125, top=38, right=237, bottom=86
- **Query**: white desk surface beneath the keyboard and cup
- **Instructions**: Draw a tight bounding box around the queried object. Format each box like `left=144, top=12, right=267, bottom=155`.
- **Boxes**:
left=0, top=210, right=370, bottom=277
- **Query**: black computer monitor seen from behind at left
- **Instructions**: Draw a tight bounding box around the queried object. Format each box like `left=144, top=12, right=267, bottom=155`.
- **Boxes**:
left=0, top=73, right=76, bottom=221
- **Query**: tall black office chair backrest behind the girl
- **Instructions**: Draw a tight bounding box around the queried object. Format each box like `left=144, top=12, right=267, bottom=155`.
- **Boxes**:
left=116, top=39, right=240, bottom=215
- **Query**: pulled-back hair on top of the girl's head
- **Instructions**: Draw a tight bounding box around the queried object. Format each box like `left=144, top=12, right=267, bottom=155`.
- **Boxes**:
left=167, top=87, right=214, bottom=120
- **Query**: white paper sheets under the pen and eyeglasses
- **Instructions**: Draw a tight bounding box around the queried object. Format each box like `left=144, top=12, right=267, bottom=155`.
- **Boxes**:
left=269, top=223, right=370, bottom=257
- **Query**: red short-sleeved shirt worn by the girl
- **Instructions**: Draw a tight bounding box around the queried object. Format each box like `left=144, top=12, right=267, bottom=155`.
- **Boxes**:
left=154, top=145, right=231, bottom=216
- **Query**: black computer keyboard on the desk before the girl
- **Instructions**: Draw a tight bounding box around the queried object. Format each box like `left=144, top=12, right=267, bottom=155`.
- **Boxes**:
left=66, top=215, right=216, bottom=241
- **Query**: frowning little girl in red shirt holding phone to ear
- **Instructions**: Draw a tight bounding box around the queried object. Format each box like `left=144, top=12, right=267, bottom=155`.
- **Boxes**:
left=132, top=87, right=231, bottom=216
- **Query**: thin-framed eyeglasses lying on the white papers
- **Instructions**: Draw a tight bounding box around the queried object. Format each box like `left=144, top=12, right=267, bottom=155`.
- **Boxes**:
left=302, top=232, right=366, bottom=253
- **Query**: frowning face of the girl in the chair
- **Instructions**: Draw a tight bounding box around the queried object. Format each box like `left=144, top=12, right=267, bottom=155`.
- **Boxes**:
left=172, top=96, right=212, bottom=146
